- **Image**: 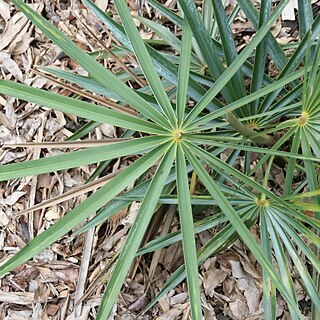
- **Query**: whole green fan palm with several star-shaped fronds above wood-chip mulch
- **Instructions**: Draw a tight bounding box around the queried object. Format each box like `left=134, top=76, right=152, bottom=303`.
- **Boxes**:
left=0, top=0, right=320, bottom=319
